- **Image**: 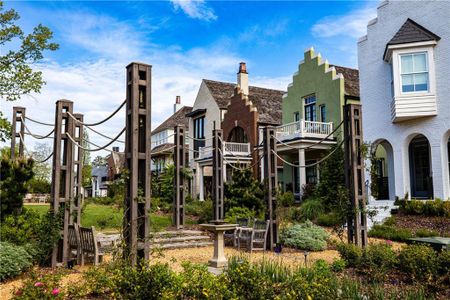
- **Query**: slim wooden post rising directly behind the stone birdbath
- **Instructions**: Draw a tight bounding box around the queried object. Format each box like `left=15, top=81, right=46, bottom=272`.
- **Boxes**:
left=212, top=129, right=224, bottom=221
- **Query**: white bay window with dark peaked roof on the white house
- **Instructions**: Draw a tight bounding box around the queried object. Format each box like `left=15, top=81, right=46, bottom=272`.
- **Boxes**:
left=383, top=19, right=440, bottom=122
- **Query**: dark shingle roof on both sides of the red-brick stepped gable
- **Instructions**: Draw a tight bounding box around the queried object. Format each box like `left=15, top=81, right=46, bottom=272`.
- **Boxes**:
left=203, top=79, right=285, bottom=124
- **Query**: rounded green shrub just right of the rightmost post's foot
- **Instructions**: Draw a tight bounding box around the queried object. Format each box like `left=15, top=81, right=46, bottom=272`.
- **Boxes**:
left=361, top=244, right=397, bottom=281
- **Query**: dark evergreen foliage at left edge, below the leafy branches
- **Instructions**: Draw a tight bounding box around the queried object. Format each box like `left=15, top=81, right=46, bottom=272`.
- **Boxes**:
left=0, top=156, right=34, bottom=219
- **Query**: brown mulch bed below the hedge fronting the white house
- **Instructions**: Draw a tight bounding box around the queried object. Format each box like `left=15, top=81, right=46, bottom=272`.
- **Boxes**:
left=393, top=213, right=450, bottom=237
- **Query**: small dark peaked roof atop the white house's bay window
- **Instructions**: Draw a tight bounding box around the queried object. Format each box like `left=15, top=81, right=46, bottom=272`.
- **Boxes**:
left=383, top=18, right=441, bottom=59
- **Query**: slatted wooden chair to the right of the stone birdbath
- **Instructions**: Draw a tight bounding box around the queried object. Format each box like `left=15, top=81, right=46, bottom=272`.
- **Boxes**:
left=238, top=219, right=269, bottom=253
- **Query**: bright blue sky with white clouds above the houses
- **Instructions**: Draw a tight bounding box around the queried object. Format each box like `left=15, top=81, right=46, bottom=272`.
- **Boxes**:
left=2, top=0, right=378, bottom=155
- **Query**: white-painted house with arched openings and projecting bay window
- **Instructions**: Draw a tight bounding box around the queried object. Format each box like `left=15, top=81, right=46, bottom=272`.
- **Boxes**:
left=358, top=1, right=450, bottom=200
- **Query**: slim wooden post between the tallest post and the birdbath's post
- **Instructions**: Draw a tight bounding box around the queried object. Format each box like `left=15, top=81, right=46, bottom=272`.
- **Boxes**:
left=173, top=125, right=186, bottom=229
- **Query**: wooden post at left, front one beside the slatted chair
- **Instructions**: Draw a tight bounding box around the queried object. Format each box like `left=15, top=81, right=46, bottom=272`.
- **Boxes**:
left=51, top=100, right=74, bottom=267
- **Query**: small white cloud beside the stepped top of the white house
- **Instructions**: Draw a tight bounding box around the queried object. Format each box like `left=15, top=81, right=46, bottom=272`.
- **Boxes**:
left=311, top=6, right=377, bottom=38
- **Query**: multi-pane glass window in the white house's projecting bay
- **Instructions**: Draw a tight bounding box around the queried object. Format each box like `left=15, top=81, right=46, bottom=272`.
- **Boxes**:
left=400, top=52, right=428, bottom=93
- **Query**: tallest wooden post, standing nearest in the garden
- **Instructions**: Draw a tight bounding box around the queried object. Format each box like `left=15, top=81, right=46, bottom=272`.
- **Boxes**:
left=123, top=63, right=152, bottom=265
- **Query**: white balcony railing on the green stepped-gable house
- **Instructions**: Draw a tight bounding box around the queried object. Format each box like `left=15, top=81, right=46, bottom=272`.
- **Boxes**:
left=277, top=120, right=333, bottom=140
